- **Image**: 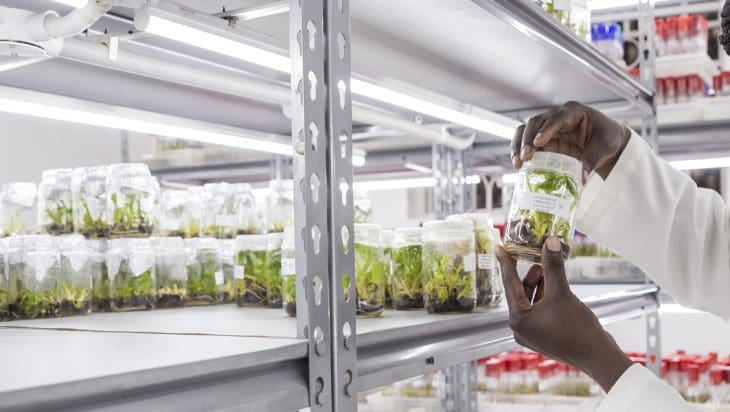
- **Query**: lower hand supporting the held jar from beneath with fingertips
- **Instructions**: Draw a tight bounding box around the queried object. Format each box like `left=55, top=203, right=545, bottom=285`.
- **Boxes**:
left=497, top=236, right=632, bottom=392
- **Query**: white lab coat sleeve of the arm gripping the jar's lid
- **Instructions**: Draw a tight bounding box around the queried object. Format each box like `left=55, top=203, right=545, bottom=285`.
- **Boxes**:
left=576, top=134, right=730, bottom=320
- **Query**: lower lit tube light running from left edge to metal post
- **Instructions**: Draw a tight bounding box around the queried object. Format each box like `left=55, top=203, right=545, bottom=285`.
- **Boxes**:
left=0, top=86, right=292, bottom=156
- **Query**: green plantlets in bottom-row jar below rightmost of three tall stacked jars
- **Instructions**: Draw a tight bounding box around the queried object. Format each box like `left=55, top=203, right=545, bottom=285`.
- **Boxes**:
left=110, top=264, right=156, bottom=311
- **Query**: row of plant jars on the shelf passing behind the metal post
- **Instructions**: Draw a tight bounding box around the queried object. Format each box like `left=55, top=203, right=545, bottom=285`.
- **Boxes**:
left=281, top=214, right=503, bottom=317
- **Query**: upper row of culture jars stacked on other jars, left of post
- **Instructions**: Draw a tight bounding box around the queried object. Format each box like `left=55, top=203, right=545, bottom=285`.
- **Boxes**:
left=0, top=164, right=294, bottom=239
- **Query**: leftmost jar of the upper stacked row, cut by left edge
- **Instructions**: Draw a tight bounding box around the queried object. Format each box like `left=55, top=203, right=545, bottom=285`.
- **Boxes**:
left=0, top=183, right=38, bottom=236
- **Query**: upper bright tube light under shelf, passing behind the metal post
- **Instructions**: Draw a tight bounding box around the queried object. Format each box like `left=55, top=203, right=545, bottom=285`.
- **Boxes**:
left=137, top=2, right=520, bottom=139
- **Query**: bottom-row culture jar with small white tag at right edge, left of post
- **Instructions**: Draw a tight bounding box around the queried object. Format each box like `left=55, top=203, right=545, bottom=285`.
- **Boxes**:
left=186, top=238, right=225, bottom=306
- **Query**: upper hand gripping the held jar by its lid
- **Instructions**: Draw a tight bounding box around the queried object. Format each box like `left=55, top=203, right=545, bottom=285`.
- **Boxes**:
left=511, top=102, right=631, bottom=180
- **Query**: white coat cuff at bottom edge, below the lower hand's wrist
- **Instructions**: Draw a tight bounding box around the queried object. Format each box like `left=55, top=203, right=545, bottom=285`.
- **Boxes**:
left=598, top=365, right=696, bottom=412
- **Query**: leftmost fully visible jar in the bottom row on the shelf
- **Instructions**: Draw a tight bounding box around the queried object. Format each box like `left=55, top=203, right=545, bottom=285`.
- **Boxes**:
left=8, top=235, right=60, bottom=319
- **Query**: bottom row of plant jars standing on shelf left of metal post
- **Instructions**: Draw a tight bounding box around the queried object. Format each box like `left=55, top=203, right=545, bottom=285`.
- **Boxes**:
left=0, top=233, right=290, bottom=320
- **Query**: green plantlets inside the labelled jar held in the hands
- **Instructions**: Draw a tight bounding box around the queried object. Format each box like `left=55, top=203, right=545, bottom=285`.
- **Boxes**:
left=505, top=170, right=578, bottom=261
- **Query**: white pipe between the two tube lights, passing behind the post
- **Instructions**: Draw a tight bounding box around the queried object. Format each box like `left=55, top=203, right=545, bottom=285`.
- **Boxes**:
left=59, top=39, right=474, bottom=149
